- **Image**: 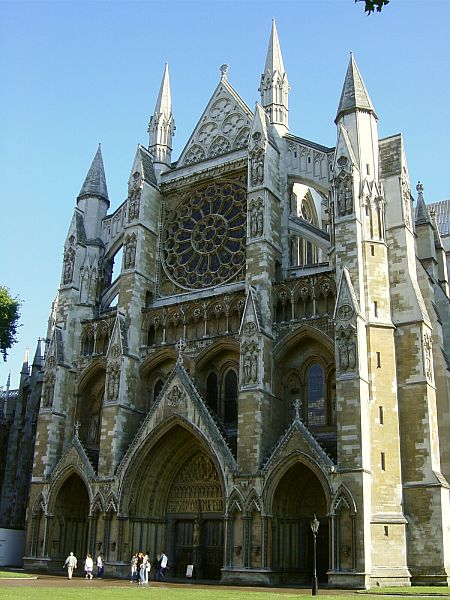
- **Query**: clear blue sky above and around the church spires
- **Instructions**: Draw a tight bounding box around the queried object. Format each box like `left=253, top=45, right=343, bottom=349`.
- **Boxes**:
left=0, top=0, right=450, bottom=386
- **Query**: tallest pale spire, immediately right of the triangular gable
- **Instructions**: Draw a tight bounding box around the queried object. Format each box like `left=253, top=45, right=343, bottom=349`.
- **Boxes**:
left=259, top=19, right=289, bottom=135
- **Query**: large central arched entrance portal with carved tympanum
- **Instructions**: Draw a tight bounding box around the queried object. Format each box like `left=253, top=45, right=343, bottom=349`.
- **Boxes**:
left=129, top=425, right=224, bottom=579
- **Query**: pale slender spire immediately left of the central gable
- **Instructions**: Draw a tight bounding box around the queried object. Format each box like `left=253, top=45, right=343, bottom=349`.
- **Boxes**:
left=148, top=63, right=175, bottom=171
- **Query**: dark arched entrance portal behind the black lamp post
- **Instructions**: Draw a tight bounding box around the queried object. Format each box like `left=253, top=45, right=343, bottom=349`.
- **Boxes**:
left=272, top=462, right=329, bottom=583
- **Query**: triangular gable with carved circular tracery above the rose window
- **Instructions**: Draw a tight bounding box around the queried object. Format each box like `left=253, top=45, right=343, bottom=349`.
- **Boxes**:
left=177, top=78, right=253, bottom=167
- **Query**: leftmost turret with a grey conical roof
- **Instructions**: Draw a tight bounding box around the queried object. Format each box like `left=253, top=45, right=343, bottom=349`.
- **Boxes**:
left=77, top=144, right=109, bottom=239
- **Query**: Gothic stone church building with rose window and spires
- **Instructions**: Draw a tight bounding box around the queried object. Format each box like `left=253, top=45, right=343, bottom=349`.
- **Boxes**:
left=25, top=23, right=450, bottom=588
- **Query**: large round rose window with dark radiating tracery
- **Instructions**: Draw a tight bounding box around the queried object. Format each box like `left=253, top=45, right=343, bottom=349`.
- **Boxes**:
left=162, top=183, right=246, bottom=289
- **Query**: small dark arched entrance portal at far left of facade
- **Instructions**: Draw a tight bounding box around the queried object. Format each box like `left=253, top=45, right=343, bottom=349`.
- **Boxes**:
left=50, top=473, right=89, bottom=560
